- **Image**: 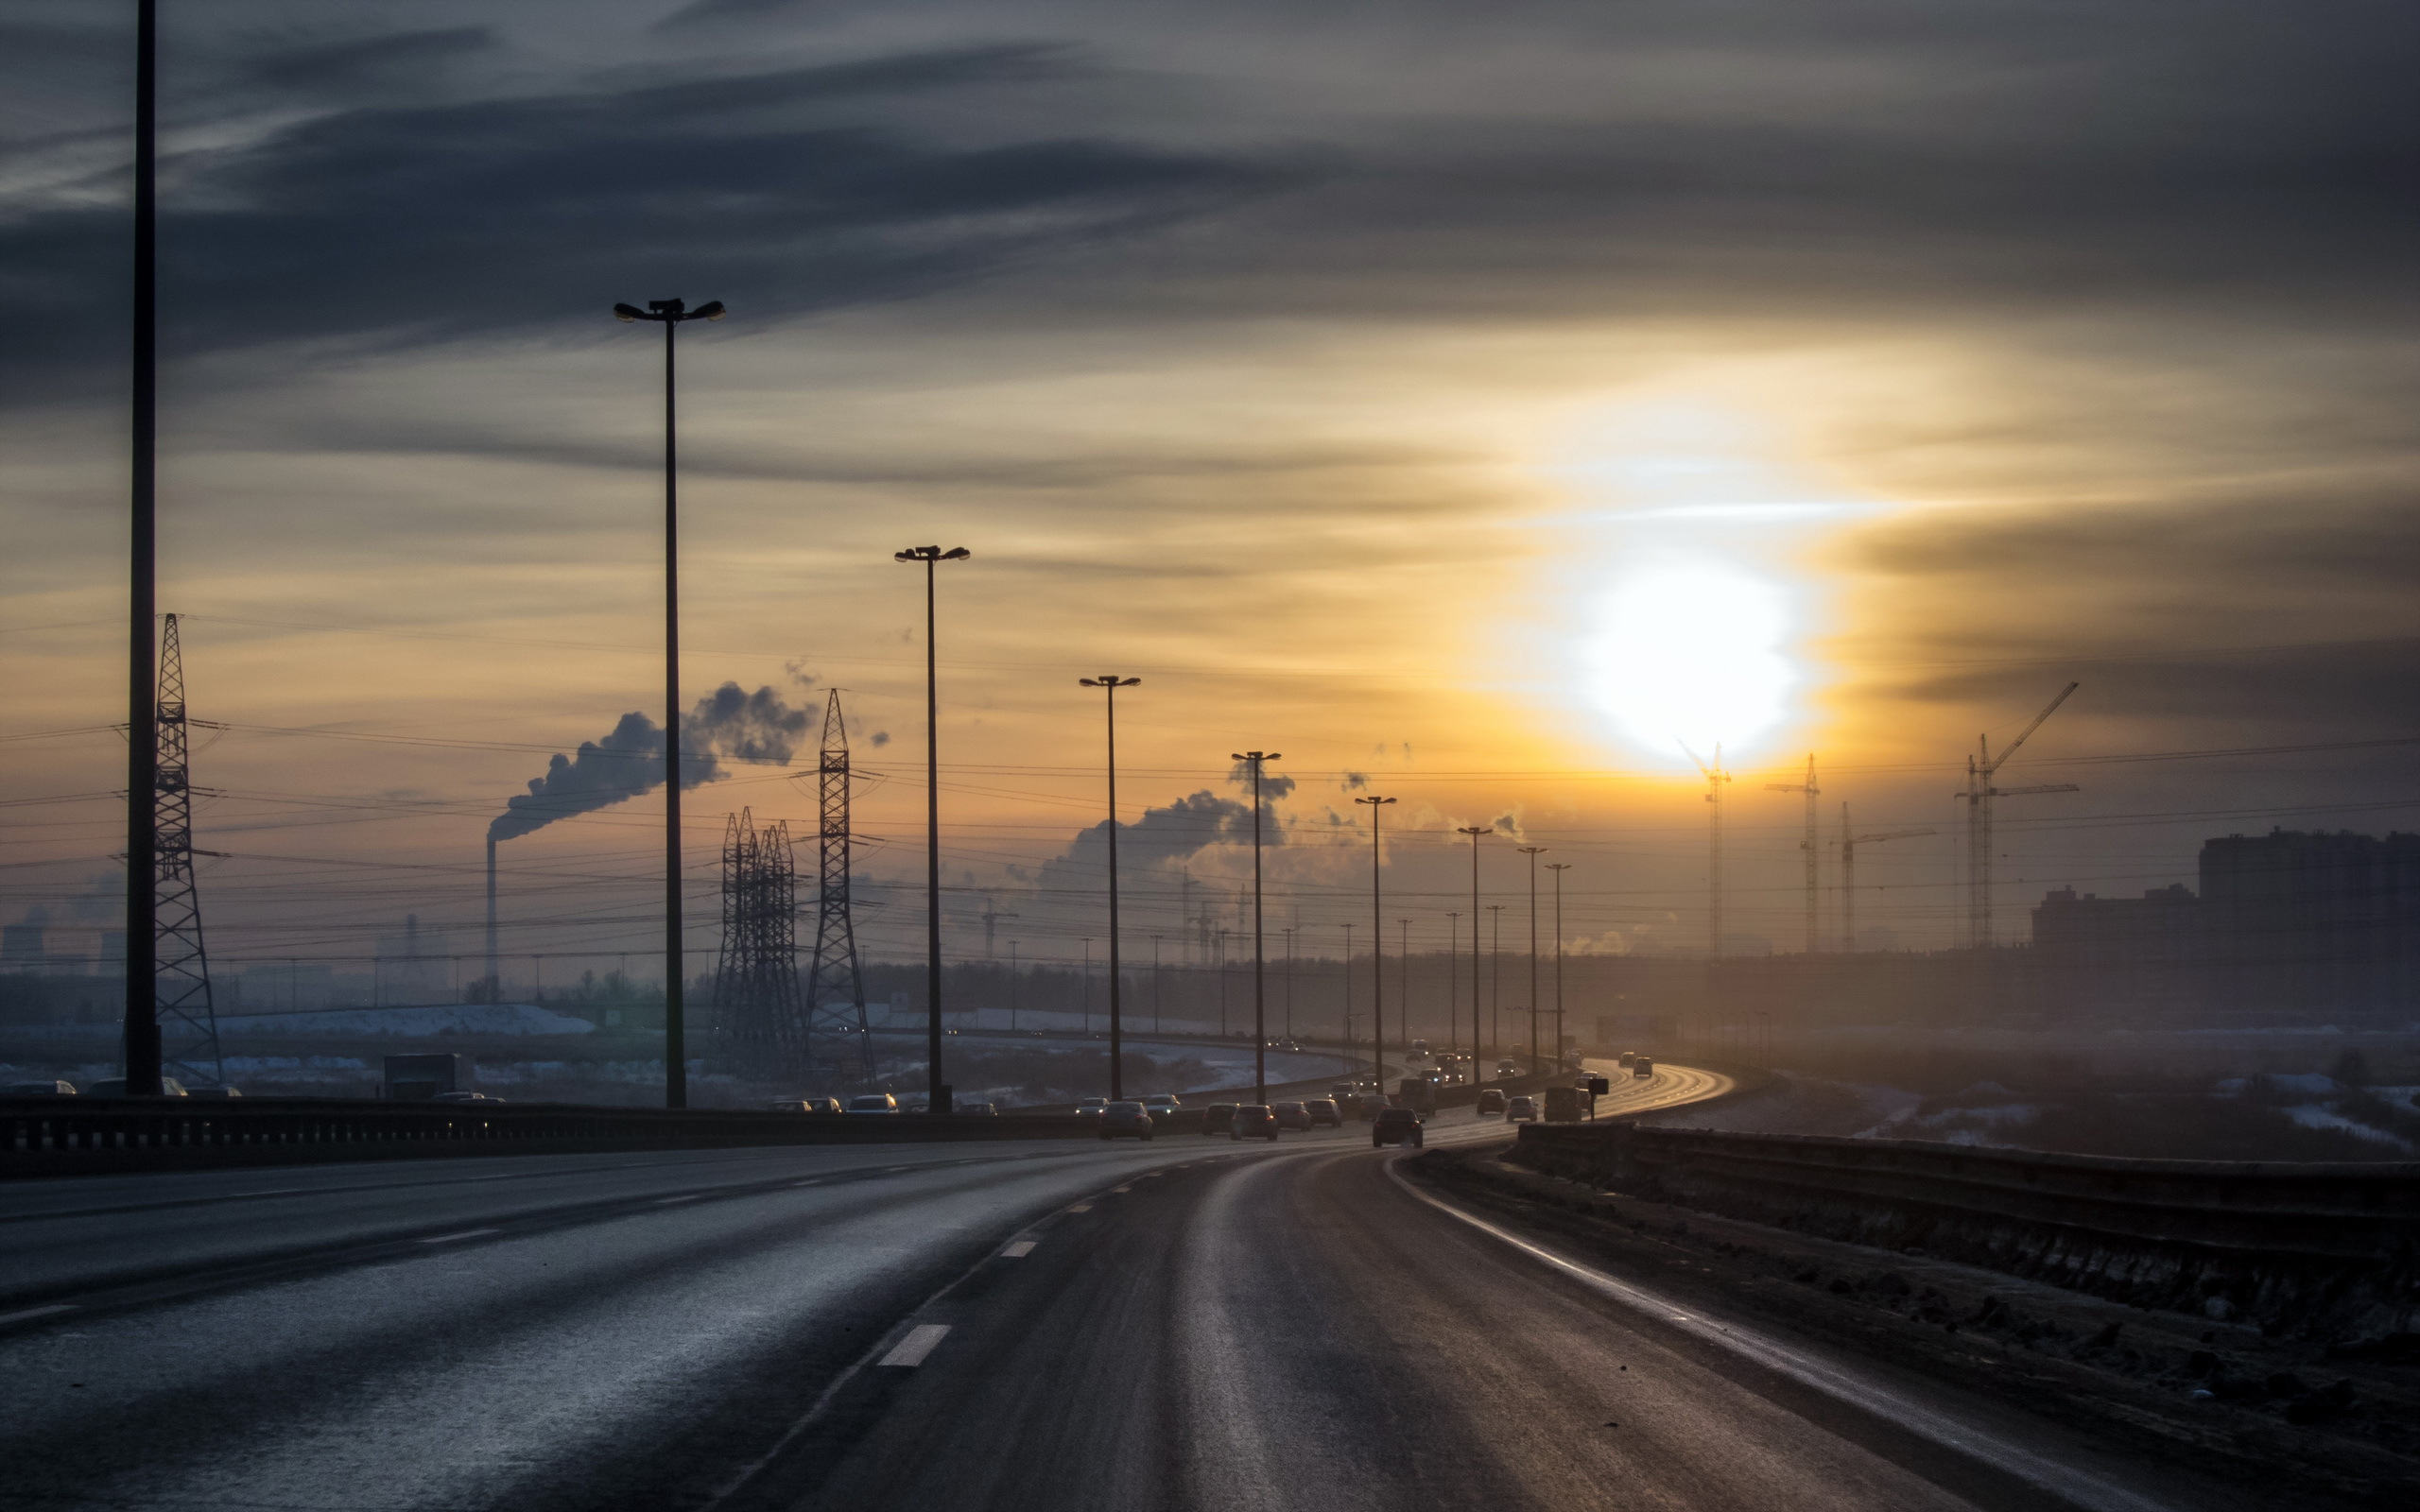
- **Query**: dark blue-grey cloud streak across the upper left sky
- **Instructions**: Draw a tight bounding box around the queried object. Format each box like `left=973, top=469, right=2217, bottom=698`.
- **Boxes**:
left=0, top=31, right=1268, bottom=401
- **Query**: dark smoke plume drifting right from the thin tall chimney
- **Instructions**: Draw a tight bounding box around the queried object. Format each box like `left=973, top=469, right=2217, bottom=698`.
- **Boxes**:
left=487, top=682, right=805, bottom=839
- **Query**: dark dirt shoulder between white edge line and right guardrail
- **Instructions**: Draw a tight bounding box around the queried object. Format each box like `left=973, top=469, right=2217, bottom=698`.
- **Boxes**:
left=1410, top=1149, right=2420, bottom=1512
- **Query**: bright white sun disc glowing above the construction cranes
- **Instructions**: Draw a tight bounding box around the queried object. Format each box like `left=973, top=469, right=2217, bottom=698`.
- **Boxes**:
left=1590, top=557, right=1798, bottom=757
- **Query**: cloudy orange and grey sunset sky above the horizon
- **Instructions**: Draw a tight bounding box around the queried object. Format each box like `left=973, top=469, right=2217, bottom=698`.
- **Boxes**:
left=0, top=0, right=2420, bottom=987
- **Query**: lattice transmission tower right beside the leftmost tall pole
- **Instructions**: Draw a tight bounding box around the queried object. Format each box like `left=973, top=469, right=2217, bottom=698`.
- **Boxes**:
left=152, top=614, right=228, bottom=1086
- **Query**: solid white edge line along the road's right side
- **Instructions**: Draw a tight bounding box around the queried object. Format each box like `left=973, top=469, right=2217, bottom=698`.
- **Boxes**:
left=1387, top=1161, right=2170, bottom=1512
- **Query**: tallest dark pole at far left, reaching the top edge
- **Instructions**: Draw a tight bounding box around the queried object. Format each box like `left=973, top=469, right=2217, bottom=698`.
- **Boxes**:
left=124, top=0, right=160, bottom=1096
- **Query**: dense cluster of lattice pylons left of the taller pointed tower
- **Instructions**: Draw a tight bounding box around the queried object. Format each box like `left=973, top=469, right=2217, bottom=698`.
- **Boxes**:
left=714, top=808, right=805, bottom=1074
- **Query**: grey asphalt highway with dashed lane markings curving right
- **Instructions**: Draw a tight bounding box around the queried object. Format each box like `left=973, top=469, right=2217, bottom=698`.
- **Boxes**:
left=0, top=1067, right=2221, bottom=1512
